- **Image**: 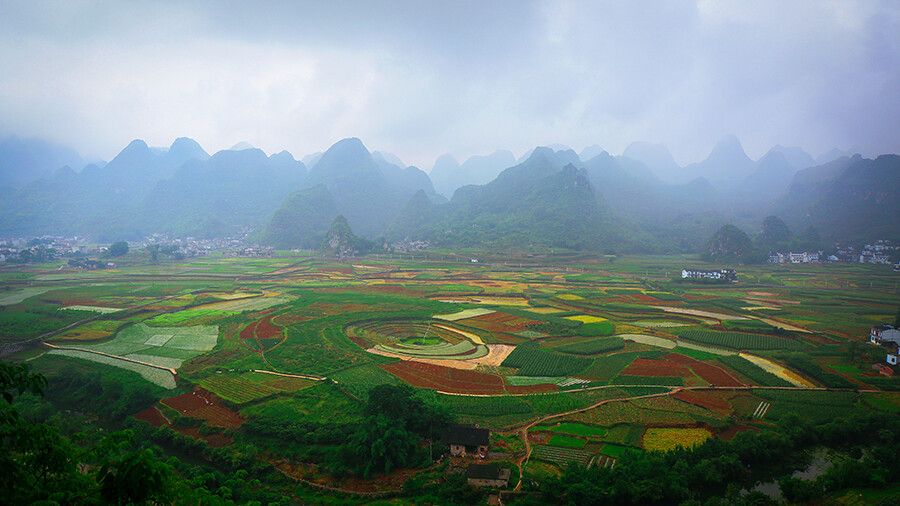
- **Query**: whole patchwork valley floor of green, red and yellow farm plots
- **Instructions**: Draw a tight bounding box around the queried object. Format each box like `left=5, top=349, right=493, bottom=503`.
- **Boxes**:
left=0, top=252, right=900, bottom=503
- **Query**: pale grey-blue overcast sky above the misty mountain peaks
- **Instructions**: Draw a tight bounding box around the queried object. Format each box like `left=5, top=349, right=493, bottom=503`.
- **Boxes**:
left=0, top=0, right=900, bottom=170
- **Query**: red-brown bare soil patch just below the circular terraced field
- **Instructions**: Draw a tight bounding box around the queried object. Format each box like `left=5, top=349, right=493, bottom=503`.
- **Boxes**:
left=380, top=361, right=503, bottom=394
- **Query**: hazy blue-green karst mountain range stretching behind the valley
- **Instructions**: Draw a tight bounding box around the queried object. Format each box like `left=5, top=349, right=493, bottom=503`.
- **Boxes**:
left=0, top=132, right=900, bottom=252
